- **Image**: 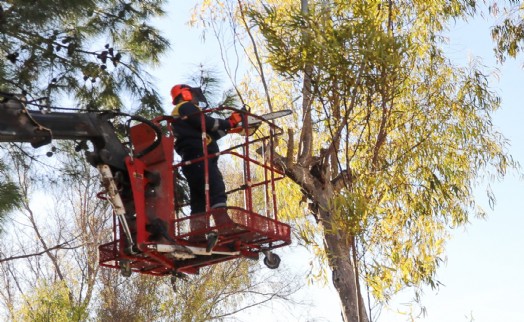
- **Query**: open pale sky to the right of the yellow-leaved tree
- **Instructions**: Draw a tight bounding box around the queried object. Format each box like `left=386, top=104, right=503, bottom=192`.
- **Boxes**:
left=412, top=18, right=524, bottom=322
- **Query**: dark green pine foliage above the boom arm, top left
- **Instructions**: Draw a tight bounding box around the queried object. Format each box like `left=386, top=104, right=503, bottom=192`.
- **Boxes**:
left=0, top=0, right=169, bottom=110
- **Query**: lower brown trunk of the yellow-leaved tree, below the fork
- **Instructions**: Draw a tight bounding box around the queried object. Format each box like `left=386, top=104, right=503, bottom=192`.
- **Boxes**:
left=319, top=211, right=369, bottom=322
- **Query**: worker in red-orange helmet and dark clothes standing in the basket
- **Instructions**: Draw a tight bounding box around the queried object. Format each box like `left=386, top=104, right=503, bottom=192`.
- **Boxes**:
left=171, top=84, right=242, bottom=252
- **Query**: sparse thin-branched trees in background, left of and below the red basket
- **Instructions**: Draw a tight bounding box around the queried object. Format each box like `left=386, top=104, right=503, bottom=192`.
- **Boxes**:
left=0, top=143, right=300, bottom=321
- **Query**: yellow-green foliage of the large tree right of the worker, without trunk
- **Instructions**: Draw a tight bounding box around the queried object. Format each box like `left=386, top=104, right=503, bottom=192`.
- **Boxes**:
left=196, top=0, right=512, bottom=306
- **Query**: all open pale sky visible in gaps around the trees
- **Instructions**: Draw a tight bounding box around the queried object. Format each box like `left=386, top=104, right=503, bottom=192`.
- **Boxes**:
left=152, top=1, right=524, bottom=322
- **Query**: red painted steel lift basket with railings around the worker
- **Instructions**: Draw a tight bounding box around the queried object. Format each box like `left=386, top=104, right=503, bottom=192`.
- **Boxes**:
left=99, top=108, right=291, bottom=275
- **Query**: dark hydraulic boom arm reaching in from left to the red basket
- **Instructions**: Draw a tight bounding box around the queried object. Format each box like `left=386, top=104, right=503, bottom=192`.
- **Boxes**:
left=0, top=97, right=155, bottom=252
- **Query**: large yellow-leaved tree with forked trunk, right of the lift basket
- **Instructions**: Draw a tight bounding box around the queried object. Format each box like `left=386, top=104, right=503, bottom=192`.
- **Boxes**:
left=194, top=0, right=515, bottom=321
